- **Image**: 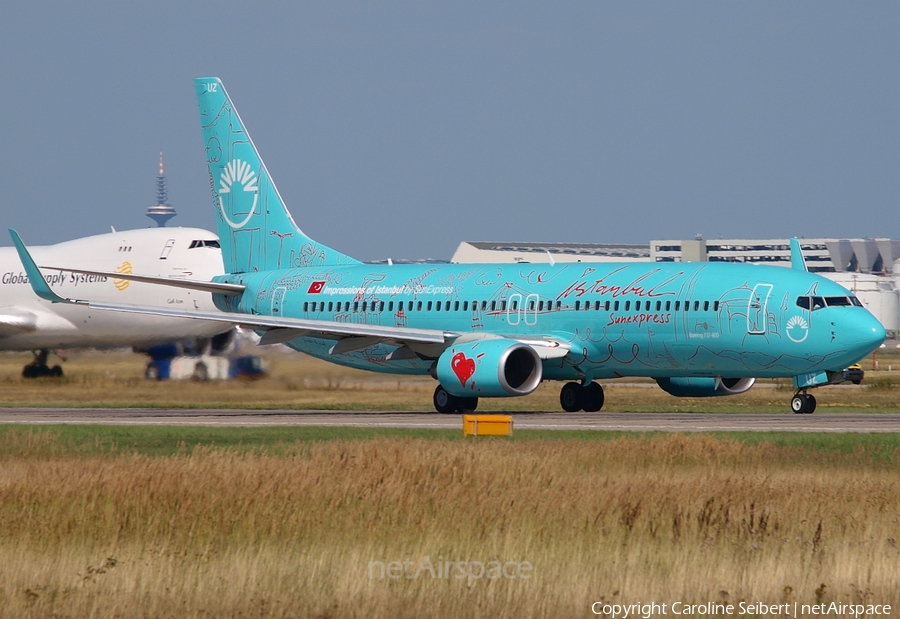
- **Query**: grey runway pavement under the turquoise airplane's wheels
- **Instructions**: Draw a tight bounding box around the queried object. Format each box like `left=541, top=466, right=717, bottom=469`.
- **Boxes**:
left=0, top=408, right=900, bottom=432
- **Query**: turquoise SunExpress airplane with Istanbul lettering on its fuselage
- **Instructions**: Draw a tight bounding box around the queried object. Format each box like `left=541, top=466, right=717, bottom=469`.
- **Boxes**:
left=10, top=78, right=885, bottom=413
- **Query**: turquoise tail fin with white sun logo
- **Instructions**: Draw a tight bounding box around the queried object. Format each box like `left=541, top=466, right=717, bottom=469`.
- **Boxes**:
left=194, top=77, right=359, bottom=273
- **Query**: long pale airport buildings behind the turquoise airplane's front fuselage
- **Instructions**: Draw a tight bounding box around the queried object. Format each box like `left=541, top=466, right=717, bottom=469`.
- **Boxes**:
left=450, top=238, right=900, bottom=337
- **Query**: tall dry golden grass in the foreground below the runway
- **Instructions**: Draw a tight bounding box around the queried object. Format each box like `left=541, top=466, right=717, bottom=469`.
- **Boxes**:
left=0, top=429, right=900, bottom=618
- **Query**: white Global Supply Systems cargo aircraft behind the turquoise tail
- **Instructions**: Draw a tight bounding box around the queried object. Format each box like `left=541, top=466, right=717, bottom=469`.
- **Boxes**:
left=0, top=228, right=231, bottom=376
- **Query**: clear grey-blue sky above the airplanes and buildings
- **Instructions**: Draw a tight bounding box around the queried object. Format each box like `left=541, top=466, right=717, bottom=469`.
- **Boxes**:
left=0, top=1, right=900, bottom=260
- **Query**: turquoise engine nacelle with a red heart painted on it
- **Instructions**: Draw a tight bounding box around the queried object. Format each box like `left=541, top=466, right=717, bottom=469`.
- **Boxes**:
left=437, top=338, right=543, bottom=398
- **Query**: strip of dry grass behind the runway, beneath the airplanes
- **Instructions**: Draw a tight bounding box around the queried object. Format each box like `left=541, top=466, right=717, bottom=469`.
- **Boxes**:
left=0, top=347, right=900, bottom=414
